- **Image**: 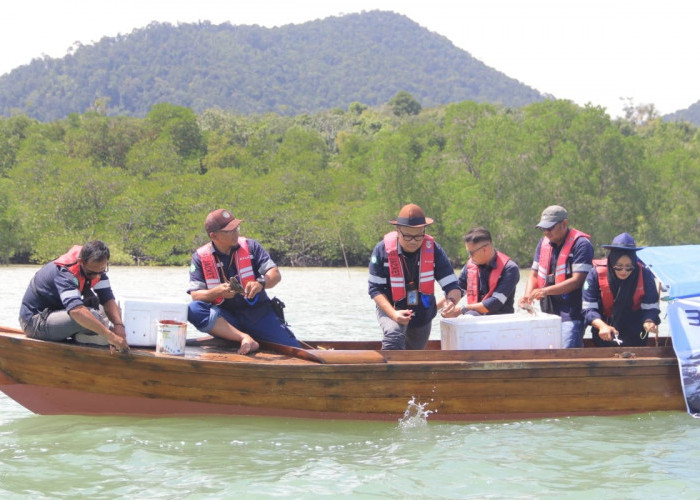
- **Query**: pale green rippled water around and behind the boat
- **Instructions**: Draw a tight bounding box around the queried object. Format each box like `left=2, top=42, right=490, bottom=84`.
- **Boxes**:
left=0, top=266, right=700, bottom=499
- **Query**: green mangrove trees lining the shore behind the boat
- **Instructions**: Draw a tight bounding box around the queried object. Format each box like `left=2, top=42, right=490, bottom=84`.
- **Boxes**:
left=0, top=98, right=700, bottom=268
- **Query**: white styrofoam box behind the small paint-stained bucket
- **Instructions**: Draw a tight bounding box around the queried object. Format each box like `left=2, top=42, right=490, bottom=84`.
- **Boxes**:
left=119, top=297, right=187, bottom=346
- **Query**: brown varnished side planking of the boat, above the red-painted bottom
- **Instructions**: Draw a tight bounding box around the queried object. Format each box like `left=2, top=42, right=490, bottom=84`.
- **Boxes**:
left=0, top=335, right=684, bottom=416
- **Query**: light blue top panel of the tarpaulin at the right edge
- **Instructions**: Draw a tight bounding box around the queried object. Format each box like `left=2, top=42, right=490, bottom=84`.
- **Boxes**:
left=637, top=245, right=700, bottom=299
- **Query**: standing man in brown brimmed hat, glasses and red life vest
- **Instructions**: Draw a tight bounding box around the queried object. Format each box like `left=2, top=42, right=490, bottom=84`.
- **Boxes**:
left=369, top=204, right=462, bottom=349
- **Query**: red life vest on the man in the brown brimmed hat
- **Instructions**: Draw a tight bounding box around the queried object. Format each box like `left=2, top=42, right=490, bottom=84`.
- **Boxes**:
left=384, top=231, right=435, bottom=302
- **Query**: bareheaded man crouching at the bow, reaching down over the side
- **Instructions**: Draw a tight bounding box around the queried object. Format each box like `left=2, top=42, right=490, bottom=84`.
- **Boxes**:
left=19, top=240, right=129, bottom=352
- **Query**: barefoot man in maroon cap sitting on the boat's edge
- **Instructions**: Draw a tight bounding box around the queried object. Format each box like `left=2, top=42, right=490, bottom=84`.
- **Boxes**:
left=187, top=209, right=299, bottom=354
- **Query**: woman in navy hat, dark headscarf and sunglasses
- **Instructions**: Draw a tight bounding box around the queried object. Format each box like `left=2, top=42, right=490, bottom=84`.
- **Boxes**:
left=583, top=233, right=661, bottom=347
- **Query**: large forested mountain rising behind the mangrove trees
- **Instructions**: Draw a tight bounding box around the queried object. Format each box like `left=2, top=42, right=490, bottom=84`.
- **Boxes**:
left=0, top=11, right=544, bottom=121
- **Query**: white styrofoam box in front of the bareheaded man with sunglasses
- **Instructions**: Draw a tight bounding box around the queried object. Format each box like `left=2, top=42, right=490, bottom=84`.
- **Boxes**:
left=440, top=312, right=561, bottom=350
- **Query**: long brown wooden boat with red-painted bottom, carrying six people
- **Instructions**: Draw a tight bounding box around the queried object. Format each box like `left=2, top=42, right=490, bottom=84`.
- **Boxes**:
left=0, top=327, right=685, bottom=421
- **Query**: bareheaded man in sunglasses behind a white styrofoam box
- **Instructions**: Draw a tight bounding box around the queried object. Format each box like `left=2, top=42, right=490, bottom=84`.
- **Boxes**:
left=438, top=227, right=520, bottom=318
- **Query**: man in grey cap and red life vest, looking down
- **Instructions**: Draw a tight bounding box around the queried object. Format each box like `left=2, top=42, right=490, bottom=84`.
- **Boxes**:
left=519, top=205, right=593, bottom=347
